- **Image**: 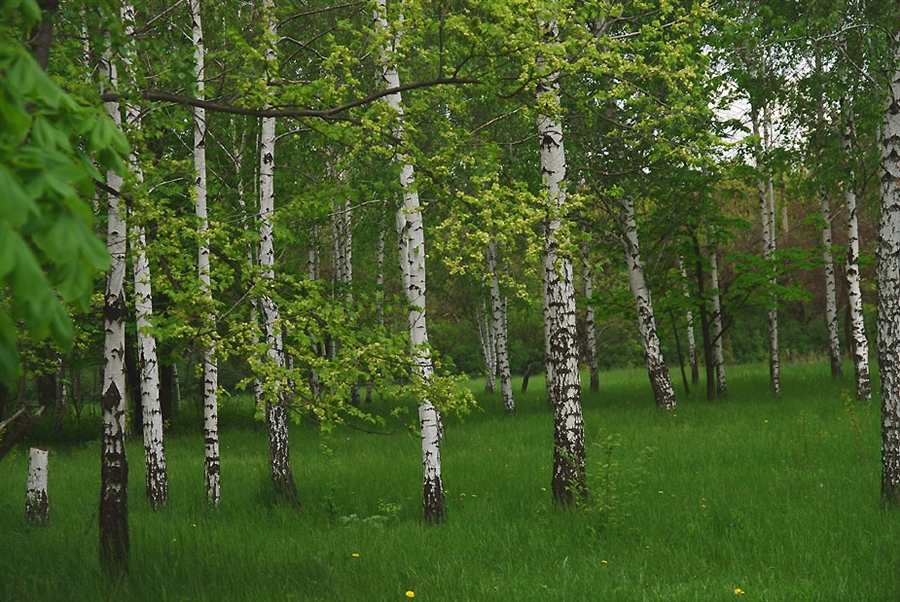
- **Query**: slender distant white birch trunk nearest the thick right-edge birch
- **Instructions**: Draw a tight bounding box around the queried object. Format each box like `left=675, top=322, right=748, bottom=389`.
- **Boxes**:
left=844, top=106, right=872, bottom=401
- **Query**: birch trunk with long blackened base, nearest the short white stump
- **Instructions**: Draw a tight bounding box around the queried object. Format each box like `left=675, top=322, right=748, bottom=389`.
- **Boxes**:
left=99, top=41, right=129, bottom=573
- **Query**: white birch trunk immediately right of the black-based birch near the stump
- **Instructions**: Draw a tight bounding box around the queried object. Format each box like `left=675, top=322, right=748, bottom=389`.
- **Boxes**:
left=121, top=3, right=169, bottom=508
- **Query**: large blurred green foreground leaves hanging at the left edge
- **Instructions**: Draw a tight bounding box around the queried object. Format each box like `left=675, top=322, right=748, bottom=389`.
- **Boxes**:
left=0, top=0, right=128, bottom=384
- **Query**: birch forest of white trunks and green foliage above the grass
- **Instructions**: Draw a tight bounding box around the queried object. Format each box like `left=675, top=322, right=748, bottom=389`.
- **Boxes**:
left=0, top=0, right=900, bottom=567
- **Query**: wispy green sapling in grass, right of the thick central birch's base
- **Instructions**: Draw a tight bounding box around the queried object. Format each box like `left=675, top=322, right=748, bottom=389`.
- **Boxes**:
left=582, top=430, right=656, bottom=533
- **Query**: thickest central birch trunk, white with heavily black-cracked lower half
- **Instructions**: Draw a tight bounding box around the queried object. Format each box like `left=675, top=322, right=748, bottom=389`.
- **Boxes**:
left=536, top=19, right=587, bottom=506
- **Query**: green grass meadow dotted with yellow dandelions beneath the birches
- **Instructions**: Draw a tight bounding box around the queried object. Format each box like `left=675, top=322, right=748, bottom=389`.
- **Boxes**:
left=0, top=364, right=900, bottom=602
